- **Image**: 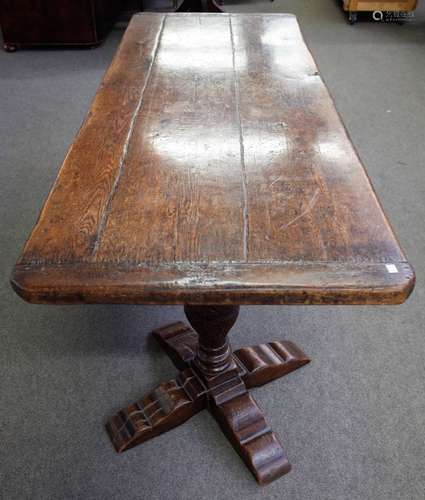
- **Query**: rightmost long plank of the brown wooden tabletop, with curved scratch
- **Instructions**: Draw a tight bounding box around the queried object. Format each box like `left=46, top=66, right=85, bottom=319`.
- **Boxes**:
left=232, top=16, right=404, bottom=262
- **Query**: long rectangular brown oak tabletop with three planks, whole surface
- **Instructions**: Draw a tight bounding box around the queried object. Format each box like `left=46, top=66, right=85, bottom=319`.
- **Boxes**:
left=12, top=13, right=414, bottom=304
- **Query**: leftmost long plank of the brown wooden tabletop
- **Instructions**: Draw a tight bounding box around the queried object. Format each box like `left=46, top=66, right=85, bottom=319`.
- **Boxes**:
left=19, top=15, right=164, bottom=263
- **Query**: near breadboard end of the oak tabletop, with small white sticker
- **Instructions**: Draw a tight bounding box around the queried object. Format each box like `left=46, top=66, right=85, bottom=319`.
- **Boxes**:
left=10, top=262, right=415, bottom=305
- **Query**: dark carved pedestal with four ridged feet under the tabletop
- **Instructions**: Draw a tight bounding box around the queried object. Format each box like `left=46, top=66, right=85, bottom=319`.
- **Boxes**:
left=106, top=306, right=309, bottom=484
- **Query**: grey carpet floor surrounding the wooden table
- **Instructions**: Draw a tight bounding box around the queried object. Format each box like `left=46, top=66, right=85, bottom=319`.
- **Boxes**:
left=0, top=0, right=425, bottom=500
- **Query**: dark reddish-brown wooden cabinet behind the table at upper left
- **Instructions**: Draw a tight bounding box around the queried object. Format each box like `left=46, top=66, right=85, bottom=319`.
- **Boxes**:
left=0, top=0, right=120, bottom=51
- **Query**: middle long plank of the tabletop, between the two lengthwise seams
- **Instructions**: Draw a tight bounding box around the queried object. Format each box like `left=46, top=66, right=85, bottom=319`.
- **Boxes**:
left=94, top=15, right=244, bottom=263
